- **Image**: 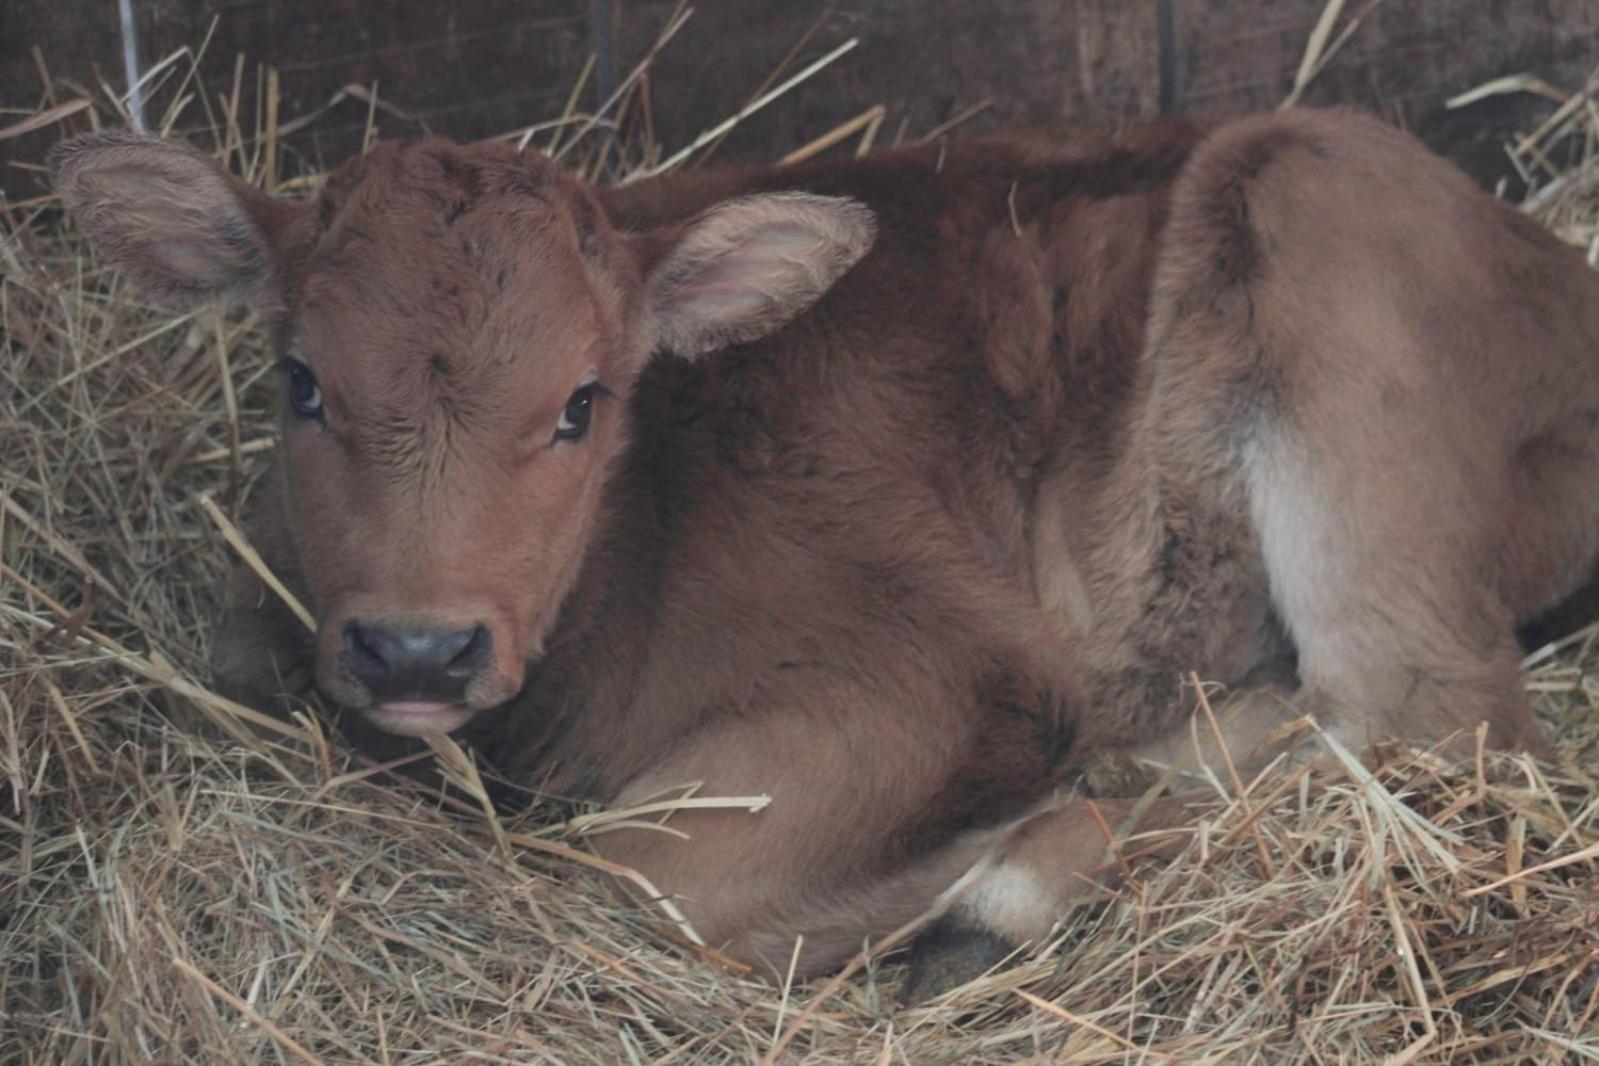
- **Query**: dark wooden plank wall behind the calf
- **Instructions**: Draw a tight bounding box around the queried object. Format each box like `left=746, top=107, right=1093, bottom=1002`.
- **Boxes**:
left=0, top=0, right=1599, bottom=197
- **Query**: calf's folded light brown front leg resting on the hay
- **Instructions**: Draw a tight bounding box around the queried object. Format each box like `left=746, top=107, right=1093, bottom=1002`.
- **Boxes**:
left=592, top=679, right=1016, bottom=977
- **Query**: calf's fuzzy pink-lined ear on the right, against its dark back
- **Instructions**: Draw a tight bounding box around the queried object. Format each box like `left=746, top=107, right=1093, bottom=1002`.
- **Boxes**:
left=649, top=192, right=876, bottom=356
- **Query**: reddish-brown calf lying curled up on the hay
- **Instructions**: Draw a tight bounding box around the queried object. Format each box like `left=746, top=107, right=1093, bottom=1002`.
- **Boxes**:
left=54, top=112, right=1599, bottom=990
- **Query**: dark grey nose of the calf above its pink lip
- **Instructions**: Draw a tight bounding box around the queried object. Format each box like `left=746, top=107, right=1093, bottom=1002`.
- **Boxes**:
left=344, top=622, right=492, bottom=703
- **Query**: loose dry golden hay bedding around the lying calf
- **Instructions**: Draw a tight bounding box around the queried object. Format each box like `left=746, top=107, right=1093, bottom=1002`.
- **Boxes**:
left=9, top=33, right=1599, bottom=1064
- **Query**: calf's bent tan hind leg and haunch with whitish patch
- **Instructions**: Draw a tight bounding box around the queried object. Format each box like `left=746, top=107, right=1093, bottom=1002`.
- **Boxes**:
left=1148, top=115, right=1561, bottom=757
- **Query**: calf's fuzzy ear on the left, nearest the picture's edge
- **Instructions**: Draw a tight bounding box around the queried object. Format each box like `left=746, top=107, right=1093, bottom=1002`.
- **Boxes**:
left=50, top=133, right=278, bottom=305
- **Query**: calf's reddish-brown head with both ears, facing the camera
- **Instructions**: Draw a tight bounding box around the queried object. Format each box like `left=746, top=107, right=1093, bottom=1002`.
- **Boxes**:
left=51, top=134, right=873, bottom=734
